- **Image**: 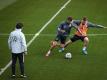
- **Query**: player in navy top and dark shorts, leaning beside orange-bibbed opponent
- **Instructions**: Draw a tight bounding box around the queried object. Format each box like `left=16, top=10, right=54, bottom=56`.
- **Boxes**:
left=46, top=17, right=72, bottom=56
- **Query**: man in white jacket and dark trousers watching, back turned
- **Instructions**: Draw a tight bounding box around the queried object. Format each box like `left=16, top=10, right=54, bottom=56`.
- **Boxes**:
left=8, top=23, right=27, bottom=78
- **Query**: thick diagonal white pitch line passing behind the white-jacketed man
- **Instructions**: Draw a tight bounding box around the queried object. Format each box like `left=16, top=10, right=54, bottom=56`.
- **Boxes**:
left=0, top=0, right=71, bottom=76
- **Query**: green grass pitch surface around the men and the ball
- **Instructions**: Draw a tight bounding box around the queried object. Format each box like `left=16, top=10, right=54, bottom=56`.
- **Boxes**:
left=0, top=0, right=107, bottom=80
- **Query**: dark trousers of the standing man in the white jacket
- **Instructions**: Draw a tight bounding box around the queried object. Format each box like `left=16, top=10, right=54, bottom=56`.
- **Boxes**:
left=12, top=53, right=24, bottom=75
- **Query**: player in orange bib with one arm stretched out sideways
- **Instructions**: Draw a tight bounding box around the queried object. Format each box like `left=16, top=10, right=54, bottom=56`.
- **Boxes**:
left=65, top=17, right=104, bottom=55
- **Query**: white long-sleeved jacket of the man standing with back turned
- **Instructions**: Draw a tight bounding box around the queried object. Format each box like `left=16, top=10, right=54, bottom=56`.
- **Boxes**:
left=8, top=29, right=27, bottom=54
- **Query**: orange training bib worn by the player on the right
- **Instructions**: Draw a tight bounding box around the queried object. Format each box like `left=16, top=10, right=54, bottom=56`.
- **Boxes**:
left=75, top=21, right=88, bottom=36
